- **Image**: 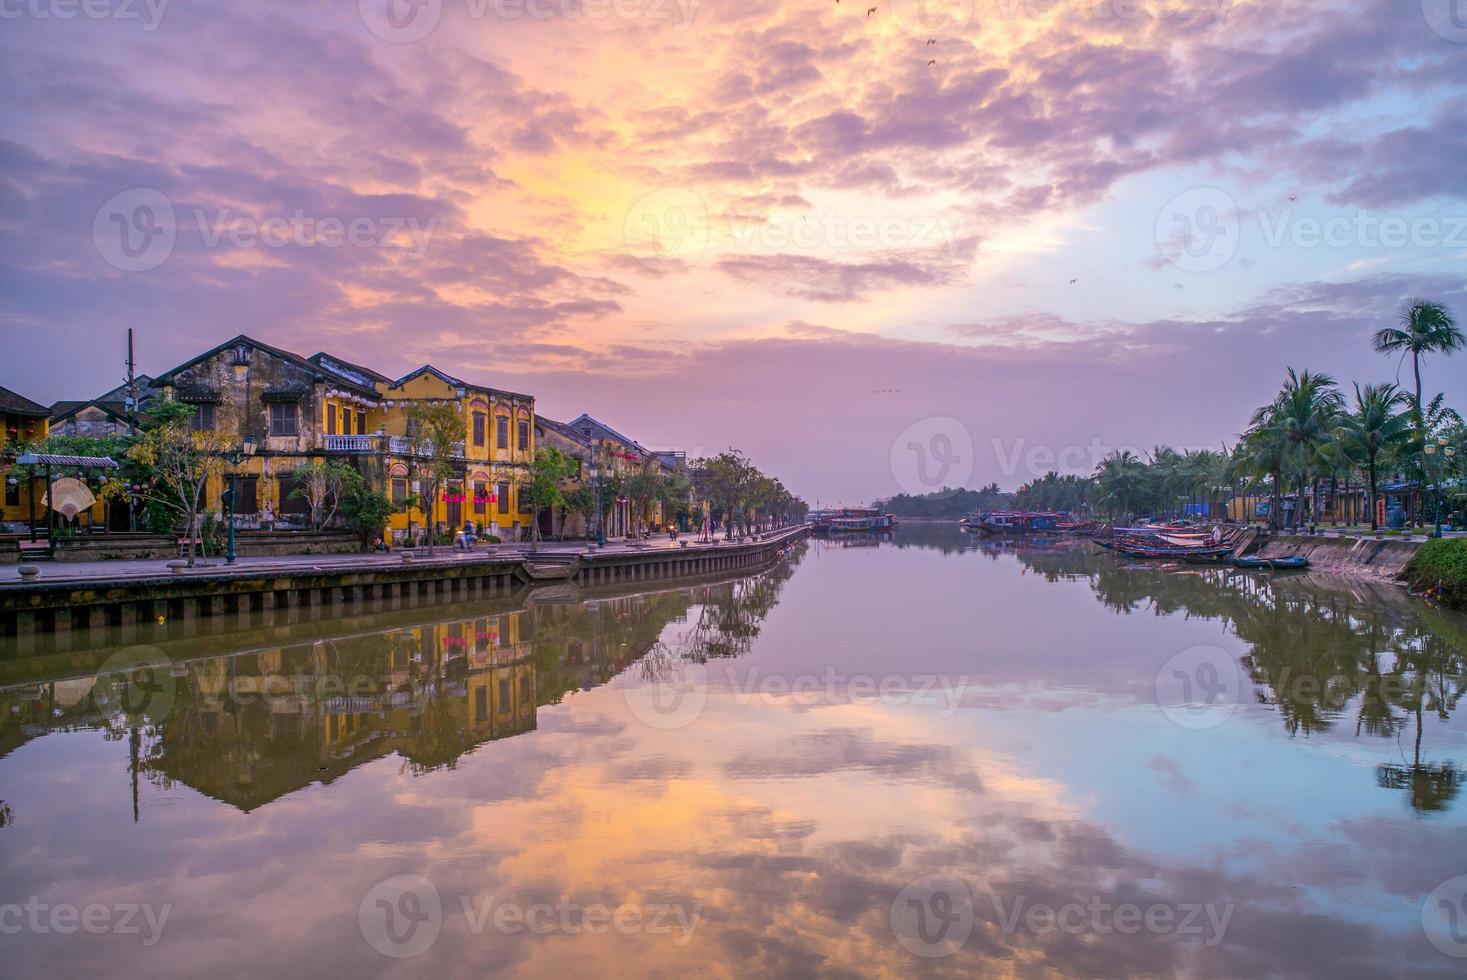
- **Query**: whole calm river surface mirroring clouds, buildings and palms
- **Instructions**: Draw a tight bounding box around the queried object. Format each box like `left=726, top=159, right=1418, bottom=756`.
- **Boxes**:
left=0, top=525, right=1467, bottom=977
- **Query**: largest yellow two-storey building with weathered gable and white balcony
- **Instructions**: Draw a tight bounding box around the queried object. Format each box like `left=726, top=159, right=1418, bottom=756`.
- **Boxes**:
left=145, top=334, right=534, bottom=543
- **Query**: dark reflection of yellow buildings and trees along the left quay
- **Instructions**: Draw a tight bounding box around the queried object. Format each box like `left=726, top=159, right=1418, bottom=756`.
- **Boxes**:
left=0, top=554, right=792, bottom=814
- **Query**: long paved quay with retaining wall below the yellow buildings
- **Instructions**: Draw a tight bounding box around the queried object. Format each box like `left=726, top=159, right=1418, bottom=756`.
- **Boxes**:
left=0, top=525, right=810, bottom=656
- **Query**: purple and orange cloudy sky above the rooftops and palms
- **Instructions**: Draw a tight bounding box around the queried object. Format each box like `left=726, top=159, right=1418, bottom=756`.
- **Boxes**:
left=0, top=0, right=1467, bottom=503
